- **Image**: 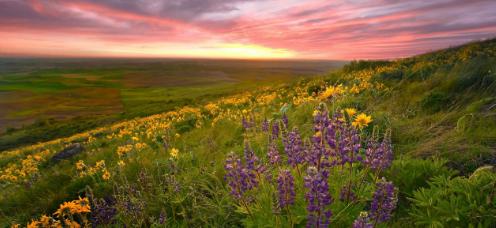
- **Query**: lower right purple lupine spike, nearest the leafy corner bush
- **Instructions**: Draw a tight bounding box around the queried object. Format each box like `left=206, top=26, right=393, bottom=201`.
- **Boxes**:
left=369, top=178, right=398, bottom=223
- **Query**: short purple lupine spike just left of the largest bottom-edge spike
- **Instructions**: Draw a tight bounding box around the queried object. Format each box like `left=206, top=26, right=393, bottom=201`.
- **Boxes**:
left=277, top=169, right=296, bottom=208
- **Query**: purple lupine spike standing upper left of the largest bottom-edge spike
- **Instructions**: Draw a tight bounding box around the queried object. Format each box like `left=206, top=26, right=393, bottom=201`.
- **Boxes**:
left=283, top=128, right=305, bottom=167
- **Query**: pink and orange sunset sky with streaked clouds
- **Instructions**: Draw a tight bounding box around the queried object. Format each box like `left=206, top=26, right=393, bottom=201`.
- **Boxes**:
left=0, top=0, right=496, bottom=60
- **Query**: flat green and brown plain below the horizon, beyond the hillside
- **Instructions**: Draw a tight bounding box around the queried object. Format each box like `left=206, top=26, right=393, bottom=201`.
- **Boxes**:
left=0, top=59, right=344, bottom=150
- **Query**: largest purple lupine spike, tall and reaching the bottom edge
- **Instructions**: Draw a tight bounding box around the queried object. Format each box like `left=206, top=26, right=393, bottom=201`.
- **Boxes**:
left=304, top=166, right=332, bottom=227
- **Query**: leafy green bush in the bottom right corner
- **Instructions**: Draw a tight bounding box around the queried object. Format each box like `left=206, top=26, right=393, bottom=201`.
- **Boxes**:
left=410, top=167, right=496, bottom=227
